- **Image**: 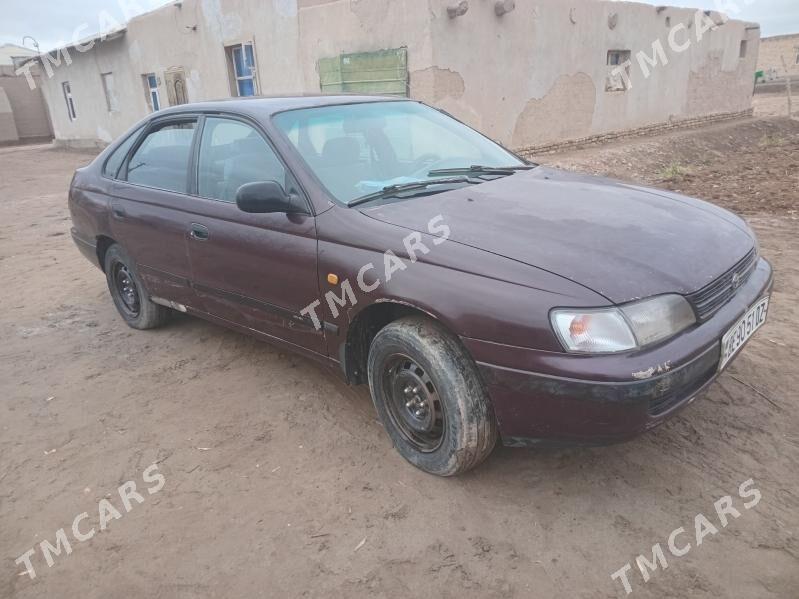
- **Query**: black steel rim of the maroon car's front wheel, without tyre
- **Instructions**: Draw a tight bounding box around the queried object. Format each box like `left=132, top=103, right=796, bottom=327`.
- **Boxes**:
left=382, top=354, right=446, bottom=453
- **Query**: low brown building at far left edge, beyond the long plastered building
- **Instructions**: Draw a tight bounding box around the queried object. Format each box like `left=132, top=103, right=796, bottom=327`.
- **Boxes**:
left=0, top=44, right=53, bottom=145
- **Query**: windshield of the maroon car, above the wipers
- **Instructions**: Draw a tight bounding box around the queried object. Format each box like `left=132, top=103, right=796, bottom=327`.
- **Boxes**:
left=274, top=101, right=524, bottom=204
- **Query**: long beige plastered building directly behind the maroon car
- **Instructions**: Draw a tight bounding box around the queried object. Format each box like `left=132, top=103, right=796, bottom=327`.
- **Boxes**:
left=25, top=0, right=760, bottom=149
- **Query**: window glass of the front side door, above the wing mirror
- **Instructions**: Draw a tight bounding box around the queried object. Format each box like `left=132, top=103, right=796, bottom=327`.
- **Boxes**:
left=197, top=117, right=287, bottom=202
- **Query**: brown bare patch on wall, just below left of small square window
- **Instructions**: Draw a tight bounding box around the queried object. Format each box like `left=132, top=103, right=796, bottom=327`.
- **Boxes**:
left=513, top=73, right=596, bottom=147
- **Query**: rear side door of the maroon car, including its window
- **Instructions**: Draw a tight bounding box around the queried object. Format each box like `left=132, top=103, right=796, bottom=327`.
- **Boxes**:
left=111, top=116, right=199, bottom=307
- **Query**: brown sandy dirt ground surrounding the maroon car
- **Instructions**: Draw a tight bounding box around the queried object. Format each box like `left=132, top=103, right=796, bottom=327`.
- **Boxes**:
left=0, top=119, right=799, bottom=599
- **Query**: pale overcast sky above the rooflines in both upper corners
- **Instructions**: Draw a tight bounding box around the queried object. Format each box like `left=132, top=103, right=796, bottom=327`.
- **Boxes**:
left=0, top=0, right=799, bottom=50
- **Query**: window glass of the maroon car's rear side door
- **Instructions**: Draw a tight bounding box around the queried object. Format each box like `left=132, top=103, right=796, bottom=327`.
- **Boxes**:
left=127, top=121, right=197, bottom=193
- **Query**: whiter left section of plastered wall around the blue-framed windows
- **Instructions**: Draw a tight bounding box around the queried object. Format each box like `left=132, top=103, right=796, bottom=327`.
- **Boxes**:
left=37, top=0, right=306, bottom=147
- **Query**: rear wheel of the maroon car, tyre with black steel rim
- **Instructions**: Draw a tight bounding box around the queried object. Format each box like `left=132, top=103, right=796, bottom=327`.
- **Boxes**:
left=104, top=244, right=171, bottom=330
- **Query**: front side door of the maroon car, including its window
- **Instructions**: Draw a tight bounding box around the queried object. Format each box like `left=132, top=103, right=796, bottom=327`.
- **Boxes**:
left=188, top=117, right=325, bottom=354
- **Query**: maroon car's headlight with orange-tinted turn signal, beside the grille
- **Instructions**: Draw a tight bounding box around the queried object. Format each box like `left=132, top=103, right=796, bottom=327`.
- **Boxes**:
left=550, top=295, right=696, bottom=354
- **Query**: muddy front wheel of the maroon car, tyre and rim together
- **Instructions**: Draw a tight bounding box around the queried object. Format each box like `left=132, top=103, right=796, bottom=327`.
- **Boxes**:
left=368, top=317, right=497, bottom=476
